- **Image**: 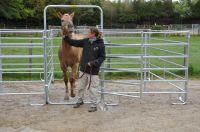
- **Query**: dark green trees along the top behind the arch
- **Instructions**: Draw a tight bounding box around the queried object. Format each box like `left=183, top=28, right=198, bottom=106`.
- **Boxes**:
left=0, top=0, right=200, bottom=27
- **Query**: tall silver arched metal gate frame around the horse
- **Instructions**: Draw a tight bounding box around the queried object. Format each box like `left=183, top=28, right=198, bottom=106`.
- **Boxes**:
left=44, top=5, right=103, bottom=105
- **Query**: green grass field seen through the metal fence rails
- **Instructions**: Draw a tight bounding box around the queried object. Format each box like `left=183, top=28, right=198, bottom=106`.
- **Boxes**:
left=1, top=36, right=200, bottom=80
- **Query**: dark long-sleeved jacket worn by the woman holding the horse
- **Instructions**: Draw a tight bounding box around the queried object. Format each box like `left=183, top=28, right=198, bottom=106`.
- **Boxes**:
left=63, top=36, right=105, bottom=75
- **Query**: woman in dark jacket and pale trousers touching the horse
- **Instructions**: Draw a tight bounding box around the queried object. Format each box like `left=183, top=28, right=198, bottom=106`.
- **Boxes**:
left=64, top=27, right=105, bottom=112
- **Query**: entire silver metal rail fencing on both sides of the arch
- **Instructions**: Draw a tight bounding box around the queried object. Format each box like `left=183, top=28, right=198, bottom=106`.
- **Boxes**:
left=0, top=28, right=190, bottom=103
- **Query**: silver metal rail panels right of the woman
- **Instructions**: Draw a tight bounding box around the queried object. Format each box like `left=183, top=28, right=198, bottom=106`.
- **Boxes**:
left=100, top=30, right=190, bottom=105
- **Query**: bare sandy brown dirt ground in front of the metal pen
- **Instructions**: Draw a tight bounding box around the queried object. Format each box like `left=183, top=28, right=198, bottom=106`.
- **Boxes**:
left=0, top=81, right=200, bottom=132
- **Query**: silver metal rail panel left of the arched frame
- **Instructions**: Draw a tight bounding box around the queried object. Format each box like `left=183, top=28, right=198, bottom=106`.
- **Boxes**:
left=0, top=29, right=45, bottom=105
